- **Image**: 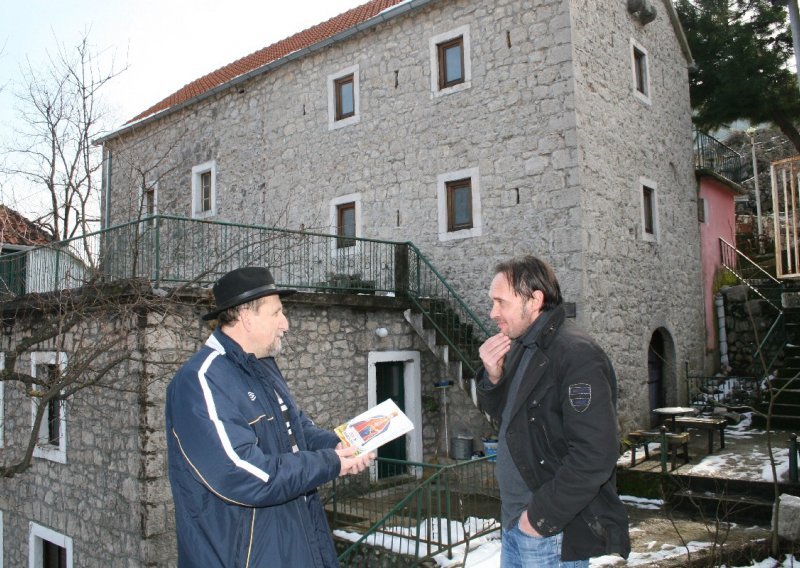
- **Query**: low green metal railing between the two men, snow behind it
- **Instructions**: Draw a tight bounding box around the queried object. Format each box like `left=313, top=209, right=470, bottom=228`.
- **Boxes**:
left=322, top=457, right=500, bottom=567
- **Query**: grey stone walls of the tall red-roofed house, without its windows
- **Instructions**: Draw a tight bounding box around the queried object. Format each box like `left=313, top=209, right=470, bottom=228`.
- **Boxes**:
left=100, top=0, right=706, bottom=430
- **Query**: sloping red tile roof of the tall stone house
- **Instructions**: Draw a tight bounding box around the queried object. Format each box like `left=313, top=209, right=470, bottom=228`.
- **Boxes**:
left=128, top=0, right=412, bottom=124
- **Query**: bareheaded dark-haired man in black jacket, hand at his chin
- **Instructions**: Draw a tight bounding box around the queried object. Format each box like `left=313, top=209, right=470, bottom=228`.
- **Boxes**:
left=478, top=256, right=630, bottom=568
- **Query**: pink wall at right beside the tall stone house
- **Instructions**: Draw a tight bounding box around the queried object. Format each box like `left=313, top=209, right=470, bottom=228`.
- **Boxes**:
left=699, top=176, right=736, bottom=349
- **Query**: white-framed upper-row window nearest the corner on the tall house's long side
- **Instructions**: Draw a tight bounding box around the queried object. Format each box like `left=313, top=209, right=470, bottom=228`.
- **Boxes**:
left=430, top=26, right=472, bottom=96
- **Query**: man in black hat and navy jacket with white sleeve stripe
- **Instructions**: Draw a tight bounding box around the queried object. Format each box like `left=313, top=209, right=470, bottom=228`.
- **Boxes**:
left=166, top=267, right=374, bottom=568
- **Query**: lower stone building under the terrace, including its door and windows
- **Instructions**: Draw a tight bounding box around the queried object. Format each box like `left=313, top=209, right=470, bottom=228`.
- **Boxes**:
left=0, top=290, right=484, bottom=568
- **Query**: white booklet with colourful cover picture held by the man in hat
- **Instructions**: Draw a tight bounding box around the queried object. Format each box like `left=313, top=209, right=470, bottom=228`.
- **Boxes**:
left=334, top=398, right=414, bottom=454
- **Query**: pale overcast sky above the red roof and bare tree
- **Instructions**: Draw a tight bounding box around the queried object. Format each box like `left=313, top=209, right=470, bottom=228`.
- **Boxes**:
left=0, top=0, right=367, bottom=214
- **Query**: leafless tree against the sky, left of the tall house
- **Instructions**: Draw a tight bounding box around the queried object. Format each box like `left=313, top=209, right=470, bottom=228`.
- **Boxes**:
left=3, top=31, right=121, bottom=240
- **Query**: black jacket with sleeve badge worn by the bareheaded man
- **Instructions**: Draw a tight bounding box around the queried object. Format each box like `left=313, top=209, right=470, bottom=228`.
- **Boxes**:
left=477, top=306, right=630, bottom=561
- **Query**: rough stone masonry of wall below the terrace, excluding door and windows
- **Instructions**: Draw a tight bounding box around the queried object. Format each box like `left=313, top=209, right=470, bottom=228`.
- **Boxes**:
left=0, top=294, right=491, bottom=568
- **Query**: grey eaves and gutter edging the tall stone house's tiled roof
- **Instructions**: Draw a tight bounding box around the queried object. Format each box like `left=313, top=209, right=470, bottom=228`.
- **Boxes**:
left=97, top=0, right=434, bottom=146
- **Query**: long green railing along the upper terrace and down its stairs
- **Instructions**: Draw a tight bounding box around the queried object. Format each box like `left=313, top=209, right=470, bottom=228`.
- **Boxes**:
left=0, top=215, right=489, bottom=372
